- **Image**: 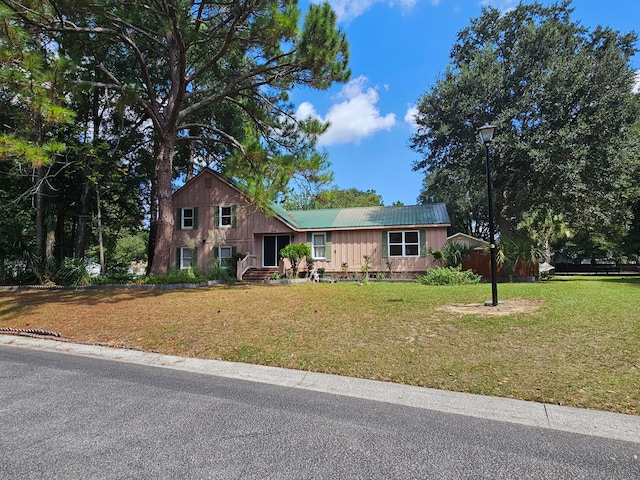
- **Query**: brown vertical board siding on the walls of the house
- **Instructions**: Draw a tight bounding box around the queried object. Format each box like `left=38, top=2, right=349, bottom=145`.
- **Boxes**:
left=171, top=170, right=447, bottom=273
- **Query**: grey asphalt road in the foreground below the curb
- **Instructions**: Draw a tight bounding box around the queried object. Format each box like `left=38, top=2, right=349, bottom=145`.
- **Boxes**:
left=0, top=344, right=640, bottom=480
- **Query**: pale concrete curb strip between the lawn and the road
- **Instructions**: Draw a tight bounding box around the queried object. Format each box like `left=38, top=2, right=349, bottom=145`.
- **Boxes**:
left=0, top=335, right=640, bottom=443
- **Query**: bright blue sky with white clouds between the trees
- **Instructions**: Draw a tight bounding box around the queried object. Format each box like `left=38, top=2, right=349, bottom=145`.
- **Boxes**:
left=291, top=0, right=640, bottom=205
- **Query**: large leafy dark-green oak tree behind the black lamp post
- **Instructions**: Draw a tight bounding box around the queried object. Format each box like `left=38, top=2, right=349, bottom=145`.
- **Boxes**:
left=411, top=1, right=638, bottom=248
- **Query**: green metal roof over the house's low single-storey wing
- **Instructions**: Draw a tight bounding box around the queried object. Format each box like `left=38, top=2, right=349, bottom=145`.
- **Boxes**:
left=272, top=203, right=450, bottom=230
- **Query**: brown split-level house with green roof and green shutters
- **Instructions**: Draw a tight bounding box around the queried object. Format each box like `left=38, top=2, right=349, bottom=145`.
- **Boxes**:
left=172, top=169, right=449, bottom=280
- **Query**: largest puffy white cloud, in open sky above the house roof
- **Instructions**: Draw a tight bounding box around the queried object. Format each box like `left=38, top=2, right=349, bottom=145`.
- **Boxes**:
left=296, top=76, right=396, bottom=146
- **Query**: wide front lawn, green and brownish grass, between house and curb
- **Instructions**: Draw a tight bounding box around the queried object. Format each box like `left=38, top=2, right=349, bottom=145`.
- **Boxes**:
left=0, top=276, right=640, bottom=415
